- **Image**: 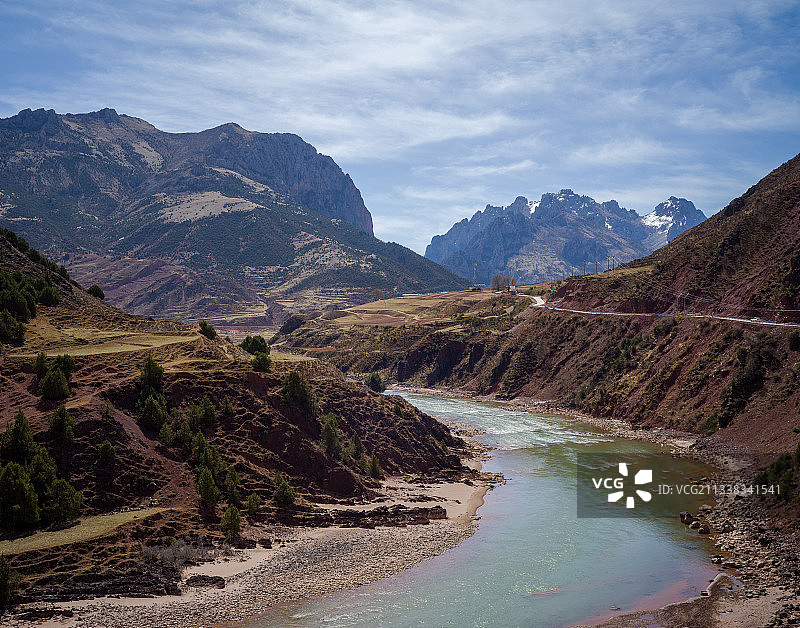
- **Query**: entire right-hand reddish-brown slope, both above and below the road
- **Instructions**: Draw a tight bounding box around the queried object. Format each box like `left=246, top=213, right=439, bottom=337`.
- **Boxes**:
left=278, top=156, right=800, bottom=446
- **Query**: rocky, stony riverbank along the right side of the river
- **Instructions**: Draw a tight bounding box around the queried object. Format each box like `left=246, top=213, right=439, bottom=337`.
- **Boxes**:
left=392, top=386, right=800, bottom=628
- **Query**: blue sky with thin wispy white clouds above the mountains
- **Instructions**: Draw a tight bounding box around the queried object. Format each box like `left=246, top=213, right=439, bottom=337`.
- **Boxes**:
left=0, top=0, right=800, bottom=252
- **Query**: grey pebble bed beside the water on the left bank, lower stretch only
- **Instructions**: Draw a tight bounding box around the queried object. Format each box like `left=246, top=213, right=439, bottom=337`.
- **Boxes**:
left=8, top=520, right=476, bottom=628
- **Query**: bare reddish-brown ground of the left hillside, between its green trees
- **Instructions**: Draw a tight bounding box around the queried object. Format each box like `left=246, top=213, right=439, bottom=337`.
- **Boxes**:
left=0, top=238, right=464, bottom=600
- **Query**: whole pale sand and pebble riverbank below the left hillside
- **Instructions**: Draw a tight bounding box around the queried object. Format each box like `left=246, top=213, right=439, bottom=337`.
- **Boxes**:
left=0, top=444, right=502, bottom=628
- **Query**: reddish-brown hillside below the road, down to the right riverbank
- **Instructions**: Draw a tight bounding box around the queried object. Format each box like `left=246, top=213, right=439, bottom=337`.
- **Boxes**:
left=278, top=292, right=800, bottom=453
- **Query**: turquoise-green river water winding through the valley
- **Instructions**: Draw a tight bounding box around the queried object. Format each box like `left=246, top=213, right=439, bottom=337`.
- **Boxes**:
left=245, top=394, right=717, bottom=628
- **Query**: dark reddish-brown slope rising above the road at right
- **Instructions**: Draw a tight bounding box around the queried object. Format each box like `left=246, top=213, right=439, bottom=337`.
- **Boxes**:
left=557, top=156, right=800, bottom=321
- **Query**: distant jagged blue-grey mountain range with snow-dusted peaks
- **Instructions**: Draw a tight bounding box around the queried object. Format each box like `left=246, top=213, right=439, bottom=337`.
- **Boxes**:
left=425, top=189, right=705, bottom=283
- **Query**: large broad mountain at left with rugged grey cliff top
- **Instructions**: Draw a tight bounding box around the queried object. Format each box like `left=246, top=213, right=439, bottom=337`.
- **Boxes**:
left=0, top=109, right=465, bottom=325
